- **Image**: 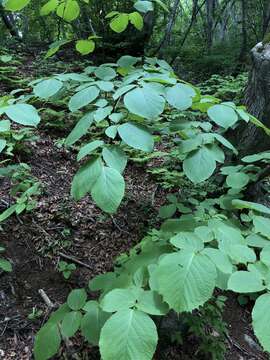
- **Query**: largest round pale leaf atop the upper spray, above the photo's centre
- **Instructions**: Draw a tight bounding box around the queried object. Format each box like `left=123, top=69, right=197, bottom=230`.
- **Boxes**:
left=124, top=88, right=165, bottom=120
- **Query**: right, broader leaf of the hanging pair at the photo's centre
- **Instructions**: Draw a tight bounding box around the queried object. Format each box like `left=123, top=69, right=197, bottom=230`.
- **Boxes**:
left=91, top=167, right=125, bottom=214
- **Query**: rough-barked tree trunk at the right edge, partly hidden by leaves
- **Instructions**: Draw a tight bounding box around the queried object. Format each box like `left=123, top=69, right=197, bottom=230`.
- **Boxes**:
left=237, top=42, right=270, bottom=156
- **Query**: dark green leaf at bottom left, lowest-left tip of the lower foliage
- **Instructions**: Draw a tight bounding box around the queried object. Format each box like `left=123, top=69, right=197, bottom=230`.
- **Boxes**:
left=34, top=323, right=61, bottom=360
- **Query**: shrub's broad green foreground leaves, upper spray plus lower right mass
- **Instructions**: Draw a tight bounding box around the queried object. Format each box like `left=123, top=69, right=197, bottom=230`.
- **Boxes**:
left=27, top=56, right=270, bottom=360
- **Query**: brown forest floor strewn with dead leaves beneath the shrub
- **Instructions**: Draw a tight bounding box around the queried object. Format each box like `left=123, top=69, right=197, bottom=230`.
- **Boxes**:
left=0, top=48, right=268, bottom=360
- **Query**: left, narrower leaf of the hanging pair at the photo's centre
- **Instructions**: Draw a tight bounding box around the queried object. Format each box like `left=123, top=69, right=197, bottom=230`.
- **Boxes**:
left=71, top=157, right=102, bottom=200
